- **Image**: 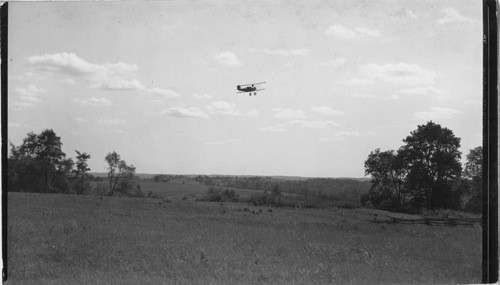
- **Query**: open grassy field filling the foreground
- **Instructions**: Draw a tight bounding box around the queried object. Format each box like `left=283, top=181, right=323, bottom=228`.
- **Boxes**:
left=6, top=193, right=481, bottom=284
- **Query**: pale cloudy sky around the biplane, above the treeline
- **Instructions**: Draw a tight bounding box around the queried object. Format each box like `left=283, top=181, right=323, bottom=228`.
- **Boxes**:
left=8, top=0, right=482, bottom=177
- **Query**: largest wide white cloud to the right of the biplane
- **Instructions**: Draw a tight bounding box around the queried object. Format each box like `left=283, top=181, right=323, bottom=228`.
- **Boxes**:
left=360, top=63, right=439, bottom=85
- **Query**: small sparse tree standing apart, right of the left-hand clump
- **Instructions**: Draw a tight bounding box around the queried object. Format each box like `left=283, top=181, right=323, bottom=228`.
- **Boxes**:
left=104, top=151, right=135, bottom=196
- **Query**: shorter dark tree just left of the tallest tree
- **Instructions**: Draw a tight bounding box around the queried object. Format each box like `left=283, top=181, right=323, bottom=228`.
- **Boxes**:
left=365, top=148, right=406, bottom=208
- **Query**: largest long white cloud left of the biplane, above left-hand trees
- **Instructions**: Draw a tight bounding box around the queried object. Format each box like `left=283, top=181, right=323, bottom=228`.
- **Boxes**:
left=28, top=52, right=145, bottom=90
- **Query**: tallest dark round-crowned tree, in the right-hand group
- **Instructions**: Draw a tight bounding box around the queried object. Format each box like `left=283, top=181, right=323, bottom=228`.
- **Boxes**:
left=399, top=121, right=462, bottom=208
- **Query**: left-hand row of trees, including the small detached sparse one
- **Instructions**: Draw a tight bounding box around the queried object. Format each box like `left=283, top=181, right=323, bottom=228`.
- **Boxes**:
left=7, top=129, right=135, bottom=195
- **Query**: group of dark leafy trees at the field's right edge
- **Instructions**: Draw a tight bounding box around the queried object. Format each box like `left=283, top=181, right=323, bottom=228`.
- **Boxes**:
left=362, top=121, right=482, bottom=212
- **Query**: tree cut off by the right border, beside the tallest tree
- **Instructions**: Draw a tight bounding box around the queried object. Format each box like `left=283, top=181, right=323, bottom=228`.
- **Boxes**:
left=463, top=146, right=483, bottom=213
